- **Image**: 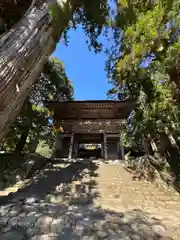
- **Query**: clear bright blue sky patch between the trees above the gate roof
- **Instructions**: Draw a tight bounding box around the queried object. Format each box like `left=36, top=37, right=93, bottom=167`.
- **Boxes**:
left=53, top=28, right=111, bottom=100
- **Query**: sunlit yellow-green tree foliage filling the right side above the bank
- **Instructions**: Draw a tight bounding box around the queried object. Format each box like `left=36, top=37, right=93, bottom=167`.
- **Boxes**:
left=106, top=0, right=180, bottom=150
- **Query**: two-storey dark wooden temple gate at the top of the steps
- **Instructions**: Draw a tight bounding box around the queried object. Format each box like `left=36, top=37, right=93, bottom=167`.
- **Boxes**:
left=45, top=100, right=133, bottom=159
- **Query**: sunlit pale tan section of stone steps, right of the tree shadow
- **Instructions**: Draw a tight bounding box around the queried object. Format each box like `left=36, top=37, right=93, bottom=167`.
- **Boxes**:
left=93, top=164, right=180, bottom=239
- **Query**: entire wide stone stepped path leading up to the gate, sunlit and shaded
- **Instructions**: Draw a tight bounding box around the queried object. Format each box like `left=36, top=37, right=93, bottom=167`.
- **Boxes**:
left=0, top=159, right=180, bottom=240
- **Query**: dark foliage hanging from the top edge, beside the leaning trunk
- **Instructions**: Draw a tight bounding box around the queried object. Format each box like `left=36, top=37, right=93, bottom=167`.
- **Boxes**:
left=49, top=0, right=110, bottom=52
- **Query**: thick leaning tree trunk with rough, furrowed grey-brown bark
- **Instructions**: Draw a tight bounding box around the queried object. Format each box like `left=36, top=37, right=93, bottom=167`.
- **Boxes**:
left=0, top=1, right=72, bottom=140
